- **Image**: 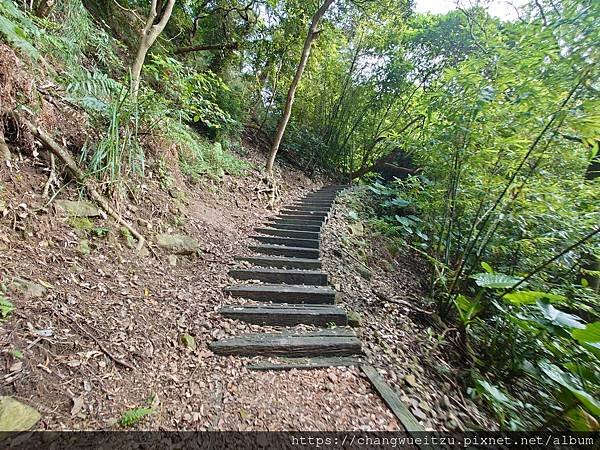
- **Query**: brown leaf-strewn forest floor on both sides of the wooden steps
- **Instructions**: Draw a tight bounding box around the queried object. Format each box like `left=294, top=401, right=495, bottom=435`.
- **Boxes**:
left=0, top=143, right=493, bottom=430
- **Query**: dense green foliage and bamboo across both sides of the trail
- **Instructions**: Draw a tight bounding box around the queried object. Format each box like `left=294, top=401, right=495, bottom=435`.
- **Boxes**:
left=0, top=0, right=600, bottom=430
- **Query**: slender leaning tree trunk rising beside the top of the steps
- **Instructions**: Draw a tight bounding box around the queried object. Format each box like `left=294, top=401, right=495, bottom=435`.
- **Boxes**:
left=267, top=0, right=335, bottom=174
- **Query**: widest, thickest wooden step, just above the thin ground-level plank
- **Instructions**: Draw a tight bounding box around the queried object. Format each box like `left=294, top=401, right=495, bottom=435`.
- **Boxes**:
left=209, top=328, right=361, bottom=357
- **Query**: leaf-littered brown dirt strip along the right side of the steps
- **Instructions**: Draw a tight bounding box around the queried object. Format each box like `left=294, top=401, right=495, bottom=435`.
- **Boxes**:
left=323, top=188, right=497, bottom=431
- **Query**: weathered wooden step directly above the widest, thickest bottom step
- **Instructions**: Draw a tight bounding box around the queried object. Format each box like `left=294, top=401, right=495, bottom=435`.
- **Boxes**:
left=219, top=305, right=348, bottom=327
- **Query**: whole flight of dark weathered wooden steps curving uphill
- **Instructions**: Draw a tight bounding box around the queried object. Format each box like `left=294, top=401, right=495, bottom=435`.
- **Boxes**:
left=210, top=186, right=362, bottom=364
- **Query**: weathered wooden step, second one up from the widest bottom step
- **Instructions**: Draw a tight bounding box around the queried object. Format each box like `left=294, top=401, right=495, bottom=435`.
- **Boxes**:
left=223, top=284, right=335, bottom=305
